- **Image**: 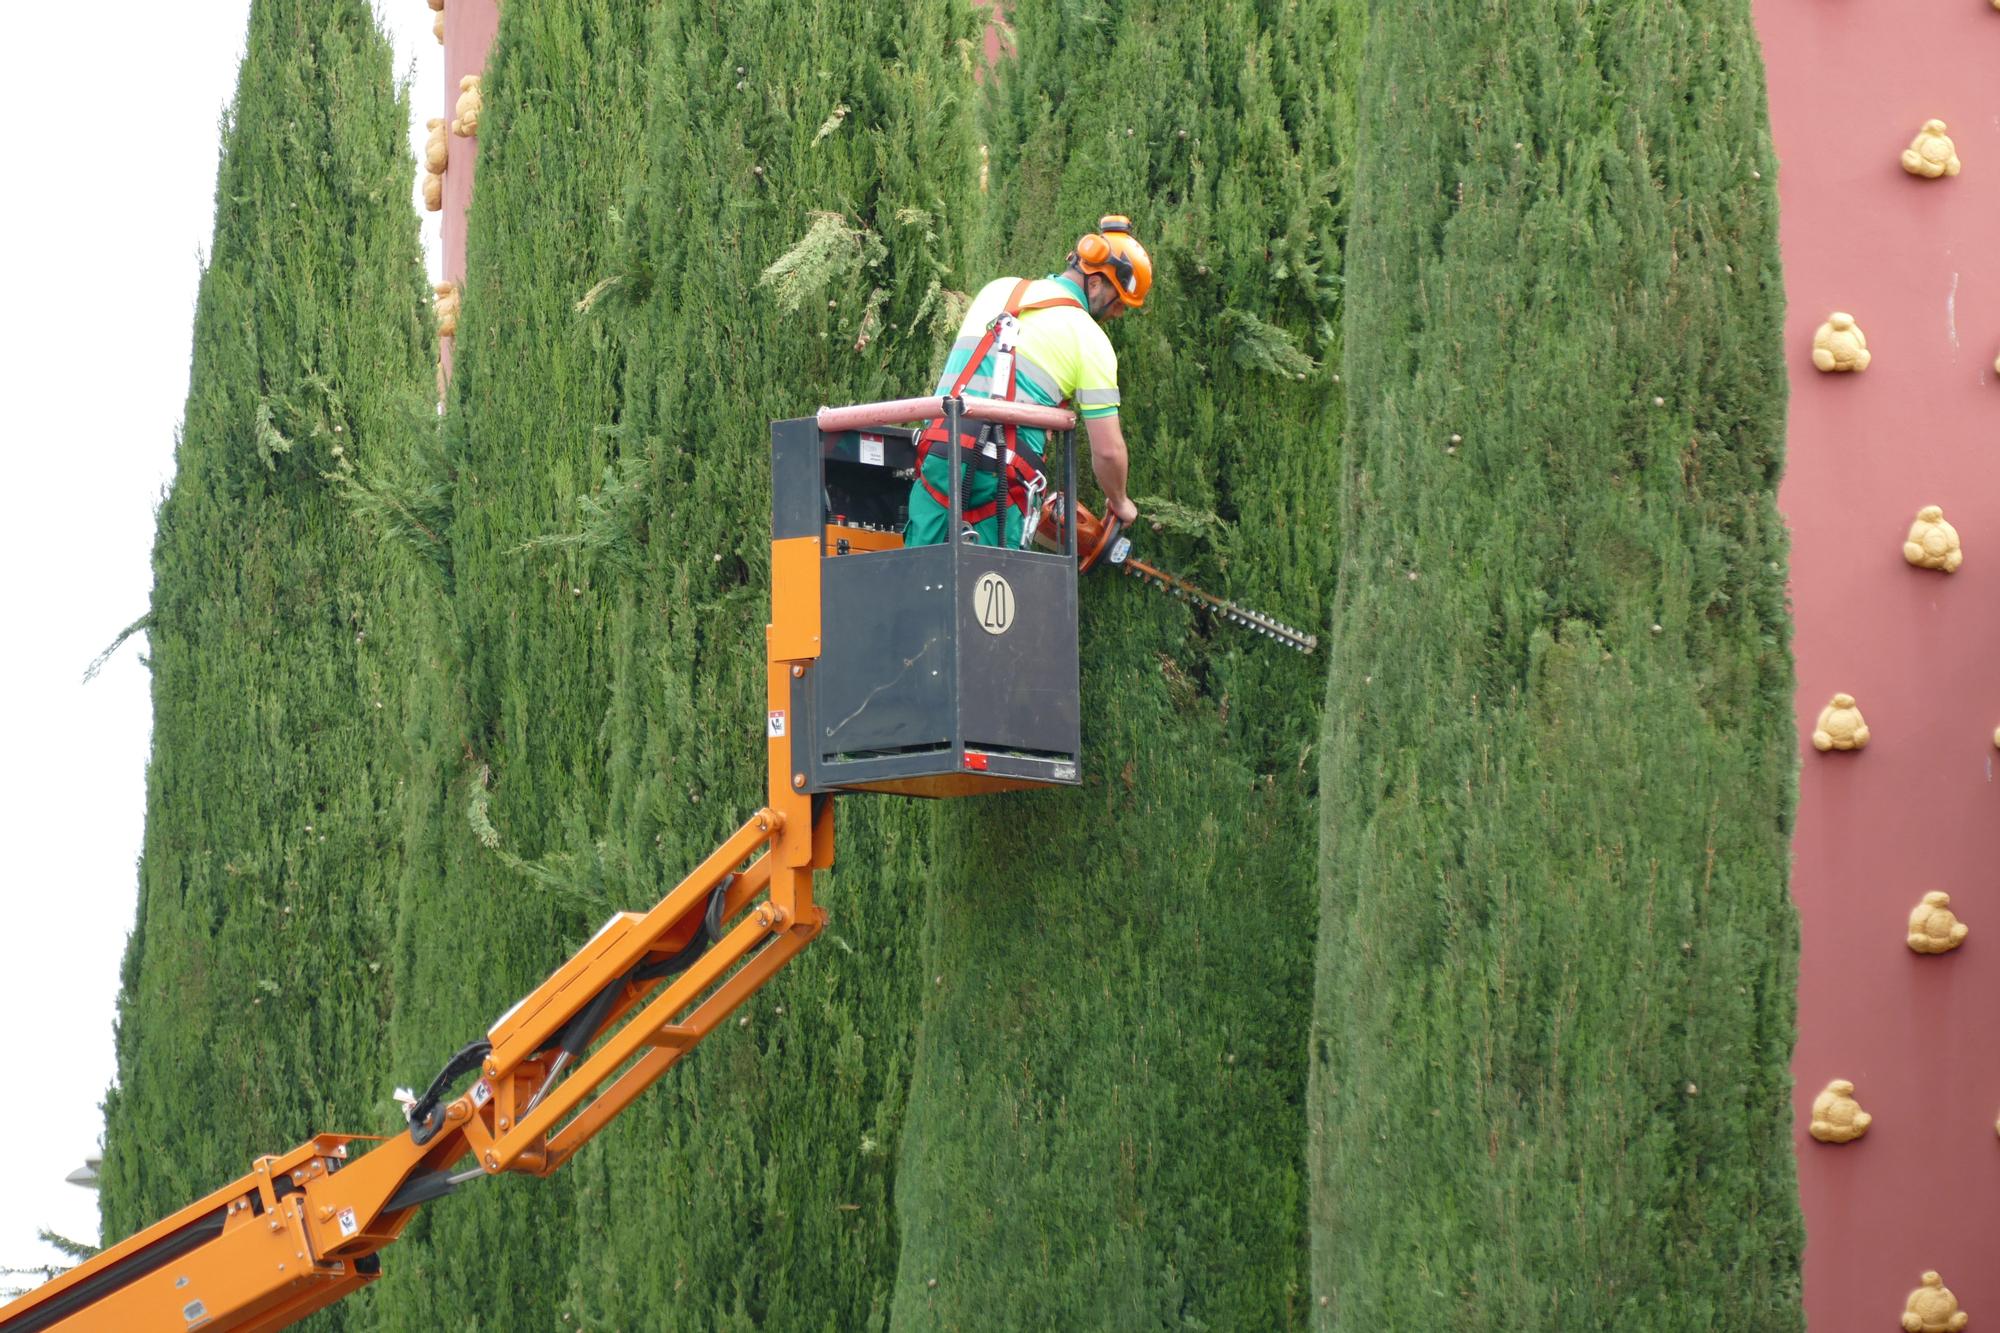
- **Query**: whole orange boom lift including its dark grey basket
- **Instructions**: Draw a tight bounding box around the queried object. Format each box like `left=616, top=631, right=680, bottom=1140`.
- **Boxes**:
left=0, top=398, right=1118, bottom=1333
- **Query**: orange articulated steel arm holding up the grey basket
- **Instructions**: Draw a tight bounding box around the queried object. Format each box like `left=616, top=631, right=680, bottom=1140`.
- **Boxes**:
left=0, top=398, right=1074, bottom=1333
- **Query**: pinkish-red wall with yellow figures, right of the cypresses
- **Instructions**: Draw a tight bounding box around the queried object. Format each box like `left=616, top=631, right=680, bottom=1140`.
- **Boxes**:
left=1754, top=0, right=2000, bottom=1329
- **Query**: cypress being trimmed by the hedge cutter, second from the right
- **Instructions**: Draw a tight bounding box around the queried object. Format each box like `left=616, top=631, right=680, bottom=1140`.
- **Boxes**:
left=892, top=0, right=1340, bottom=1329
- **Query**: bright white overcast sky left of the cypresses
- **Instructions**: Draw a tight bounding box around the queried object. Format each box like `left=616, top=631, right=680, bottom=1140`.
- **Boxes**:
left=0, top=0, right=448, bottom=1289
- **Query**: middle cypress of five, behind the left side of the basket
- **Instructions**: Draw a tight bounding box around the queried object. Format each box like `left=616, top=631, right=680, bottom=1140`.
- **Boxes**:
left=574, top=0, right=976, bottom=1331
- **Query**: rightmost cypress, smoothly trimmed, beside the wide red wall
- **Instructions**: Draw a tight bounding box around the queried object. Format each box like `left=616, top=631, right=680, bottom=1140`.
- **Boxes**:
left=1308, top=0, right=1802, bottom=1329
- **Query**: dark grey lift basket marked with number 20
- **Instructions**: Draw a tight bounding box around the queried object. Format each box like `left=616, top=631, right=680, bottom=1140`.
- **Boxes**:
left=770, top=398, right=1082, bottom=797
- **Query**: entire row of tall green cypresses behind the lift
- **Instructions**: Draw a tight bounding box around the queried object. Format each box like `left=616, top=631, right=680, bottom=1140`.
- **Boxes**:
left=104, top=0, right=1800, bottom=1333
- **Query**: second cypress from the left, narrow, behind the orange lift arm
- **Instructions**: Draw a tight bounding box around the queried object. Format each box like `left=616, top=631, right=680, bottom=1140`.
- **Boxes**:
left=380, top=0, right=650, bottom=1329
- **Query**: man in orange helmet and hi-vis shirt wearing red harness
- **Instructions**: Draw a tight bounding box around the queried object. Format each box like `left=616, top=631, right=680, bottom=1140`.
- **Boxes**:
left=902, top=214, right=1152, bottom=546
